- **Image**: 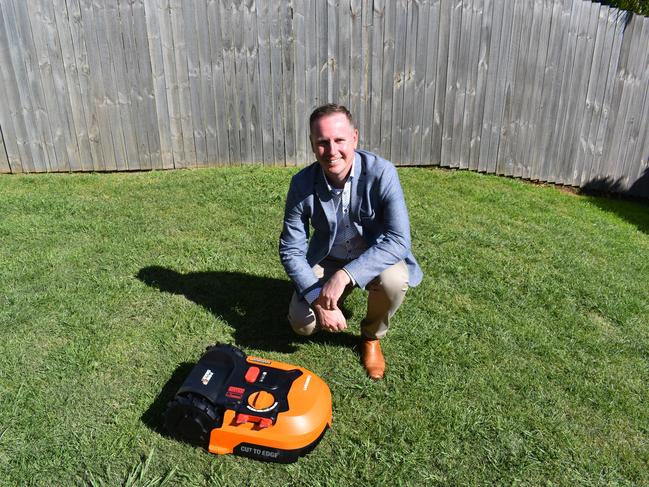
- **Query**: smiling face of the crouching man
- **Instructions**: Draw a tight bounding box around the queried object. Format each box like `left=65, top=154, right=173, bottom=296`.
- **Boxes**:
left=311, top=113, right=358, bottom=185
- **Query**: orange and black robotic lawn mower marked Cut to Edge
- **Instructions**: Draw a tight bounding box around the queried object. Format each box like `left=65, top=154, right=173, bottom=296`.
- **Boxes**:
left=165, top=345, right=332, bottom=463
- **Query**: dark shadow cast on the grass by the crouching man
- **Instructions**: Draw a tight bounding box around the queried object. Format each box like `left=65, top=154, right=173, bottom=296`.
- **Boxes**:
left=136, top=266, right=357, bottom=353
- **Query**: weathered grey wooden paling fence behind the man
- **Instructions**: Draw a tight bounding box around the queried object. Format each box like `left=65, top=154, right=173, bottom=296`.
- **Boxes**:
left=0, top=0, right=649, bottom=196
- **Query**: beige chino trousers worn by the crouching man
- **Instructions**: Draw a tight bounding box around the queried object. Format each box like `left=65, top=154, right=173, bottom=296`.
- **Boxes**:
left=288, top=257, right=408, bottom=339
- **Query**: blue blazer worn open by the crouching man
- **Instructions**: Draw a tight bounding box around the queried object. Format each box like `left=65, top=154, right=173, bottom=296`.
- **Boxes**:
left=279, top=150, right=423, bottom=296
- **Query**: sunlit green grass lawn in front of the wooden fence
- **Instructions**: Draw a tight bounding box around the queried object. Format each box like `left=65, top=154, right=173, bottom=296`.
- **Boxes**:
left=0, top=167, right=649, bottom=486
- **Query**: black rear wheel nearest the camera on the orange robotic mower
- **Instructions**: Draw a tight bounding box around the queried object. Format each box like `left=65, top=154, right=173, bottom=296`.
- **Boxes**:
left=165, top=393, right=223, bottom=448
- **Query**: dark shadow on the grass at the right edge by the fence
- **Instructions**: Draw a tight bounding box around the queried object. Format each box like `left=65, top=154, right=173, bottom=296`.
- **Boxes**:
left=581, top=169, right=649, bottom=234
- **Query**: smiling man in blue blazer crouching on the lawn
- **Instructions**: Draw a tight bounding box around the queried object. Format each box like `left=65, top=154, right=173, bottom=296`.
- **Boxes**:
left=279, top=104, right=422, bottom=380
